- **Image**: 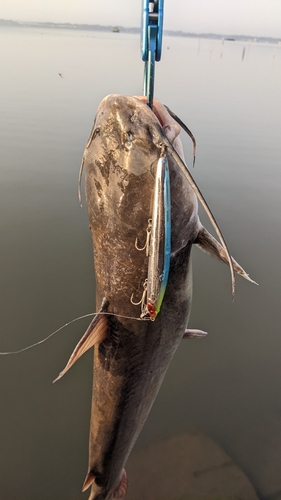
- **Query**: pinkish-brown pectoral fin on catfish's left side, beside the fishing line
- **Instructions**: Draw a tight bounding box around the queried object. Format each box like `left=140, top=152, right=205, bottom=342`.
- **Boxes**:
left=53, top=299, right=109, bottom=383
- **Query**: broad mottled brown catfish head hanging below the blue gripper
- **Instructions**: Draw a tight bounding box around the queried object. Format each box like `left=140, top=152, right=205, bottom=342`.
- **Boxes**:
left=84, top=94, right=197, bottom=315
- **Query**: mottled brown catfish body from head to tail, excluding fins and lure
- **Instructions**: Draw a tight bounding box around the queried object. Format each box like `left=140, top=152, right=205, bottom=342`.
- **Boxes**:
left=80, top=95, right=236, bottom=500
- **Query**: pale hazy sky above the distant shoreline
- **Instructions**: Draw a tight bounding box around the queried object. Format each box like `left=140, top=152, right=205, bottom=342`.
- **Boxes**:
left=0, top=0, right=281, bottom=39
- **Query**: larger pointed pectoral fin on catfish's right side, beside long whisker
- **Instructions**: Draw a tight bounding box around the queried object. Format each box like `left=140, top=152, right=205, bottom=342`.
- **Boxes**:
left=194, top=226, right=257, bottom=285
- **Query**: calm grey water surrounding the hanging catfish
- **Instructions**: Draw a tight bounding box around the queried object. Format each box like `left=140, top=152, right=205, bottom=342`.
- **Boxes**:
left=0, top=28, right=281, bottom=500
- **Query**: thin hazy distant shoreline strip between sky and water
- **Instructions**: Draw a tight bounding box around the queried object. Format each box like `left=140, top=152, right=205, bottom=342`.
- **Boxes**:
left=0, top=19, right=281, bottom=45
